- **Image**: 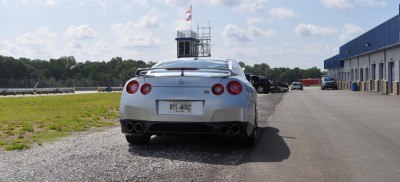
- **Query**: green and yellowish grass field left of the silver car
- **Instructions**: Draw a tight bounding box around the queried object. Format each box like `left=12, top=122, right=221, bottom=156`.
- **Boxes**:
left=0, top=93, right=121, bottom=150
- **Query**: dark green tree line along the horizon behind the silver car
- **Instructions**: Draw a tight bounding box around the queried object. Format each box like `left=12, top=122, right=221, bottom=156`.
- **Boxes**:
left=0, top=56, right=322, bottom=88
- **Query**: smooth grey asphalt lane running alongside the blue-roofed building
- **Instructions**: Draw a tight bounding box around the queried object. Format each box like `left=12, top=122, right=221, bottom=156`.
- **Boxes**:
left=241, top=88, right=400, bottom=181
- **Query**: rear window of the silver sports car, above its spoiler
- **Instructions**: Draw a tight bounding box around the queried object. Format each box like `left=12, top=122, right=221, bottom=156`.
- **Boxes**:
left=153, top=59, right=229, bottom=69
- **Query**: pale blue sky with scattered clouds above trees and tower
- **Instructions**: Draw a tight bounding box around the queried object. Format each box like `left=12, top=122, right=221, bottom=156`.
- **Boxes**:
left=0, top=0, right=400, bottom=69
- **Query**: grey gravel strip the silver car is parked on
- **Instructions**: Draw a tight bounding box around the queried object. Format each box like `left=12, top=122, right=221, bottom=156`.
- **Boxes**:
left=0, top=94, right=283, bottom=181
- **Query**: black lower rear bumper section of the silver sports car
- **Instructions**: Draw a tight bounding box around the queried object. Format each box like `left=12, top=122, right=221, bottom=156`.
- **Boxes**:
left=120, top=119, right=254, bottom=137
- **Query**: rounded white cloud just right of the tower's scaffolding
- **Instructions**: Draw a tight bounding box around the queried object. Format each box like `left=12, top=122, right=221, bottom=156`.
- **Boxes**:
left=222, top=24, right=251, bottom=46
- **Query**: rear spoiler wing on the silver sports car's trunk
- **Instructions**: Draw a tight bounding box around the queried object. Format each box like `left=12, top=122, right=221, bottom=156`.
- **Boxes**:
left=135, top=67, right=237, bottom=77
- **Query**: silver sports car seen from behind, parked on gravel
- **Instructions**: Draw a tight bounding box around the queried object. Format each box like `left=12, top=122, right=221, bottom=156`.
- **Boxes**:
left=119, top=58, right=257, bottom=147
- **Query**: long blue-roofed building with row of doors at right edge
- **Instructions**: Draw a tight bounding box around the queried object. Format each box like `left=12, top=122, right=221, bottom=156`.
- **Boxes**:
left=324, top=6, right=400, bottom=95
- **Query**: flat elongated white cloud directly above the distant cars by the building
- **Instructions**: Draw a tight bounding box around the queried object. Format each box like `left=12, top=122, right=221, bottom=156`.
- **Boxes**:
left=295, top=24, right=337, bottom=36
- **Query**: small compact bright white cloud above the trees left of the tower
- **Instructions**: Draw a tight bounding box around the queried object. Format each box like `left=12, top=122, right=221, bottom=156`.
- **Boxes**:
left=64, top=25, right=97, bottom=40
